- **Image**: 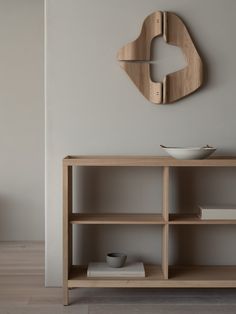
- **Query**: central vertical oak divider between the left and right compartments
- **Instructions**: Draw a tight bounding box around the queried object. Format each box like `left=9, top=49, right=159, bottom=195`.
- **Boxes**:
left=162, top=166, right=170, bottom=279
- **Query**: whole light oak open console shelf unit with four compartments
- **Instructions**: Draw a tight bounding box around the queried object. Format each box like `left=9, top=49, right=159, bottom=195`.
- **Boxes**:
left=63, top=156, right=236, bottom=305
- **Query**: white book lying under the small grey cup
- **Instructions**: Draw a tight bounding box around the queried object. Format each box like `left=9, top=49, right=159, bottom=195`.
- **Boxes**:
left=87, top=263, right=145, bottom=278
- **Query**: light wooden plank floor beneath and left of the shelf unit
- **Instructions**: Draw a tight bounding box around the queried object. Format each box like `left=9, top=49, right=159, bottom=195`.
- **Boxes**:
left=0, top=242, right=236, bottom=314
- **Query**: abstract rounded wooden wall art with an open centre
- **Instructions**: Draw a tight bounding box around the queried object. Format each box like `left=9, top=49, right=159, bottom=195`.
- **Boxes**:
left=118, top=11, right=203, bottom=104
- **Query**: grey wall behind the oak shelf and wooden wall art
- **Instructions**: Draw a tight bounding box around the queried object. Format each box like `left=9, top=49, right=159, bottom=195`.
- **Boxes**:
left=46, top=0, right=236, bottom=285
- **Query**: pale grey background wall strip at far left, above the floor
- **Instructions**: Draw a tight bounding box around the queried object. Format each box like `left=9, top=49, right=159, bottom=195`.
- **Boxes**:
left=0, top=0, right=44, bottom=241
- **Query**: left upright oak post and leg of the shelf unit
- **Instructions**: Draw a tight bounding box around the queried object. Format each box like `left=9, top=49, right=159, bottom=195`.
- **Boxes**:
left=63, top=164, right=72, bottom=305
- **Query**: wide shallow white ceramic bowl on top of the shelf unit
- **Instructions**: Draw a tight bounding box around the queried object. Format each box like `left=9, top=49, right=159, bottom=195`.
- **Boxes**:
left=160, top=145, right=216, bottom=159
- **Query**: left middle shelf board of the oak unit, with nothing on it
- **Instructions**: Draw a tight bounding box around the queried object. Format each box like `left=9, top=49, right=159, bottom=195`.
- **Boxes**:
left=70, top=213, right=165, bottom=225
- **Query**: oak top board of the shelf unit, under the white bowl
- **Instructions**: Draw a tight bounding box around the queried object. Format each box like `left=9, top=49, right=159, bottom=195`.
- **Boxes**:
left=63, top=155, right=236, bottom=167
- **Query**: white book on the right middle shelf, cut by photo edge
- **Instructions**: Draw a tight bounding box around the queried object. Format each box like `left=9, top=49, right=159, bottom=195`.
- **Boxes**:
left=199, top=205, right=236, bottom=220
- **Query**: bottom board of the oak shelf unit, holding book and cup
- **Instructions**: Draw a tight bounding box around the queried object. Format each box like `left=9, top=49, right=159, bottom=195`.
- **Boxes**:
left=68, top=265, right=236, bottom=288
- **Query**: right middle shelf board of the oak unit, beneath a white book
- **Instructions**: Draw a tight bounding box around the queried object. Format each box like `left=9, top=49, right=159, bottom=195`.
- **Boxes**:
left=168, top=214, right=236, bottom=225
